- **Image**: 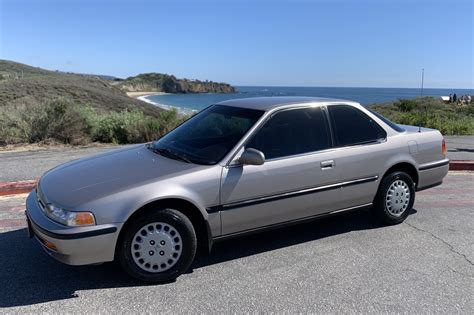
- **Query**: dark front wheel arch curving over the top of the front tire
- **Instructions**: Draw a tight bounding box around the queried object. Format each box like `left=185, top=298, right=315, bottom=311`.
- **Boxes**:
left=115, top=198, right=212, bottom=256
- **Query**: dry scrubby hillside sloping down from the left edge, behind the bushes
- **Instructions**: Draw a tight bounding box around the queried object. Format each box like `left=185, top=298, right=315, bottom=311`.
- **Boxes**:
left=0, top=60, right=161, bottom=117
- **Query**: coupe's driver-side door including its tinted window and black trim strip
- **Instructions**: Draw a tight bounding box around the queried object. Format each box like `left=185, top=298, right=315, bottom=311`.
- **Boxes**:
left=220, top=107, right=339, bottom=235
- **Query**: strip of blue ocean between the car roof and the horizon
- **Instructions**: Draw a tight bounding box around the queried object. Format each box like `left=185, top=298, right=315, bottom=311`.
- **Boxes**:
left=146, top=86, right=473, bottom=113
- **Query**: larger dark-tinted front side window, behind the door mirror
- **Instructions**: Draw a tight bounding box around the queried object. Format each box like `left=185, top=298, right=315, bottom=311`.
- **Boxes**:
left=246, top=107, right=330, bottom=159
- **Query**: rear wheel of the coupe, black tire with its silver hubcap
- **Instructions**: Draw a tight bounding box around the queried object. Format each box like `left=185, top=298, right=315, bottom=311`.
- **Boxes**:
left=372, top=172, right=415, bottom=224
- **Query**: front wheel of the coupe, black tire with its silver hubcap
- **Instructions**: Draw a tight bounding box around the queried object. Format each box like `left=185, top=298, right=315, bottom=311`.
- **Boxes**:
left=118, top=209, right=197, bottom=283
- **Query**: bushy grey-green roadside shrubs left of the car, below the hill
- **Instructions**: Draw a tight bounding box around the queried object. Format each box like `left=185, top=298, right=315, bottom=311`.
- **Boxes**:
left=0, top=98, right=187, bottom=146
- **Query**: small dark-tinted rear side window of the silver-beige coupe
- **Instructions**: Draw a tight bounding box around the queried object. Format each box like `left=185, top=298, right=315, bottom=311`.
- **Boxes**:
left=328, top=105, right=387, bottom=146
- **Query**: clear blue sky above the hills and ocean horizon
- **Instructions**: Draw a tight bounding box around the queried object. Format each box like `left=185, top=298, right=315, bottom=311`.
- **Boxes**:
left=0, top=0, right=474, bottom=88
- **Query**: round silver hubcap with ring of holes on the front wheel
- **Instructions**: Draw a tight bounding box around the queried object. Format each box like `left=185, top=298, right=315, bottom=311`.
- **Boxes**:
left=131, top=222, right=183, bottom=273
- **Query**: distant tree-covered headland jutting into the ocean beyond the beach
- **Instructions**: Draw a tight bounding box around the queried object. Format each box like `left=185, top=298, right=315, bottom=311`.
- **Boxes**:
left=118, top=73, right=235, bottom=93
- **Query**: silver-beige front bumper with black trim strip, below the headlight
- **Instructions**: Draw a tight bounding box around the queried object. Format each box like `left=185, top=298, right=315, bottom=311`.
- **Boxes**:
left=26, top=190, right=122, bottom=265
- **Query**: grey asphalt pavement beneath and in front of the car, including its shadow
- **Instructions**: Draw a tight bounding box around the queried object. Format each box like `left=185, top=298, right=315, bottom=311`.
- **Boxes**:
left=0, top=172, right=474, bottom=314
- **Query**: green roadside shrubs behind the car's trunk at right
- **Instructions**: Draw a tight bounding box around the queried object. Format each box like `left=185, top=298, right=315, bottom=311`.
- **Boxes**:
left=370, top=97, right=474, bottom=135
